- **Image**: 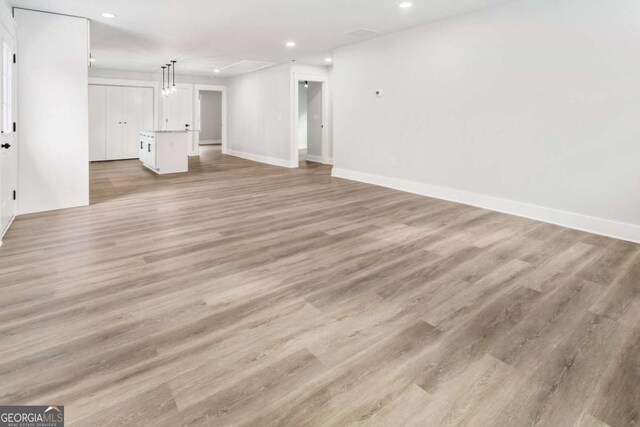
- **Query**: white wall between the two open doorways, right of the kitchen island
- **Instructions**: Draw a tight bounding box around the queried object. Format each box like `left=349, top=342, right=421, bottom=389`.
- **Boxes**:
left=227, top=63, right=298, bottom=167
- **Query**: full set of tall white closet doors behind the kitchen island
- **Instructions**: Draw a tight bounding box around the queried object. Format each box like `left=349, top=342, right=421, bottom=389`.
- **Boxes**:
left=89, top=85, right=154, bottom=161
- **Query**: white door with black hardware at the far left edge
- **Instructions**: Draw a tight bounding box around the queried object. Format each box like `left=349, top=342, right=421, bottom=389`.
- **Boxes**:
left=0, top=28, right=18, bottom=237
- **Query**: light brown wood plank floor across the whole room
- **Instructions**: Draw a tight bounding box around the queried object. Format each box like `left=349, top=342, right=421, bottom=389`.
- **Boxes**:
left=0, top=147, right=640, bottom=426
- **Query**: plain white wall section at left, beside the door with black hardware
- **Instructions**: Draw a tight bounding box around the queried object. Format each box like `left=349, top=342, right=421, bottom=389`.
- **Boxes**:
left=15, top=9, right=89, bottom=214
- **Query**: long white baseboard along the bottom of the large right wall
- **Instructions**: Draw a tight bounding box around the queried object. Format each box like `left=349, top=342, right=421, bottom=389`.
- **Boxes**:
left=331, top=168, right=640, bottom=243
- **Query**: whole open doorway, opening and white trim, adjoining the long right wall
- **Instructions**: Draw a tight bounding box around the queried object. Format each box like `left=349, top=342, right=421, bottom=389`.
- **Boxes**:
left=292, top=75, right=328, bottom=166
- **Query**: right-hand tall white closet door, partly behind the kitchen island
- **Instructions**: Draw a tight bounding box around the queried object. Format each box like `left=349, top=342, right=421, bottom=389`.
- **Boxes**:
left=123, top=87, right=153, bottom=159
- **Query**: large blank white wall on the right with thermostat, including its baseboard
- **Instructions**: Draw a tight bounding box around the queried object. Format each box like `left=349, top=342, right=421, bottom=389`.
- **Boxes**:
left=333, top=0, right=640, bottom=241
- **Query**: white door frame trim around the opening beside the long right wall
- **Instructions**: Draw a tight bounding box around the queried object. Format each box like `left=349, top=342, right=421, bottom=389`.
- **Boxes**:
left=290, top=72, right=329, bottom=168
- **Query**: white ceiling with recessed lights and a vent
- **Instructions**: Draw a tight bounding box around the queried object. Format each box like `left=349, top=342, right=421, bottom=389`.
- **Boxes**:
left=10, top=0, right=511, bottom=77
